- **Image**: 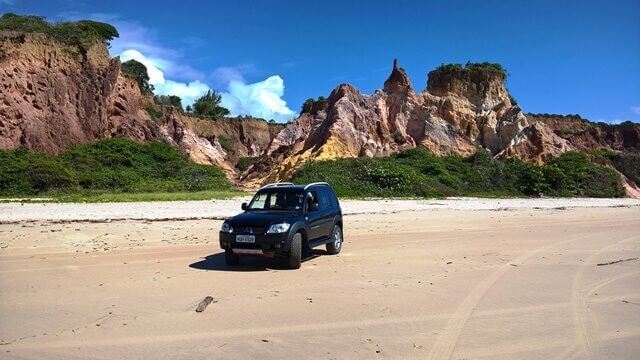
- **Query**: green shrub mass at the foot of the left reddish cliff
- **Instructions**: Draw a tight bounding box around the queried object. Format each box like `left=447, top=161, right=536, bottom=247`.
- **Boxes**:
left=0, top=139, right=233, bottom=197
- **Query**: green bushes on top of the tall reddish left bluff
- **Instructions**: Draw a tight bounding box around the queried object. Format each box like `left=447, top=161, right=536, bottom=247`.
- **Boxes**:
left=0, top=13, right=119, bottom=49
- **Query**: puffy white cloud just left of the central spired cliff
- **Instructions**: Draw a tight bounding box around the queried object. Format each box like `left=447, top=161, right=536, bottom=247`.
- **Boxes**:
left=222, top=75, right=296, bottom=121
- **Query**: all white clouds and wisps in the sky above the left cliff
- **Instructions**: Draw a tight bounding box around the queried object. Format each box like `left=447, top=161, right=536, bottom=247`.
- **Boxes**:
left=64, top=13, right=296, bottom=121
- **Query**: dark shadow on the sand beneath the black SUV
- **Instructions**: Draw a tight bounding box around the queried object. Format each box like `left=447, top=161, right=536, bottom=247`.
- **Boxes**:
left=189, top=249, right=327, bottom=272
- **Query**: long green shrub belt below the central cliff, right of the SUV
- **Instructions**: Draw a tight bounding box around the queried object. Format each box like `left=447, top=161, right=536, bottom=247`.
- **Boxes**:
left=293, top=148, right=625, bottom=197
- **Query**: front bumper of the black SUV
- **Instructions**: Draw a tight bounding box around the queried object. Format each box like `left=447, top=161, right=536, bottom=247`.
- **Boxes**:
left=219, top=232, right=290, bottom=256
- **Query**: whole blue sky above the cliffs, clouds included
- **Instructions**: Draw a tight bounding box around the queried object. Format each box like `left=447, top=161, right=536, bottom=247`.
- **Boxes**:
left=0, top=0, right=640, bottom=122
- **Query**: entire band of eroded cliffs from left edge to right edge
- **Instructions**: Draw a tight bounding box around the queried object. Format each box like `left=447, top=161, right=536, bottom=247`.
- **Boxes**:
left=0, top=32, right=640, bottom=187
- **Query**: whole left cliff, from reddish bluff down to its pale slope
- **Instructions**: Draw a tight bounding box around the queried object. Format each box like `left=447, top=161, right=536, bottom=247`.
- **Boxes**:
left=0, top=32, right=281, bottom=180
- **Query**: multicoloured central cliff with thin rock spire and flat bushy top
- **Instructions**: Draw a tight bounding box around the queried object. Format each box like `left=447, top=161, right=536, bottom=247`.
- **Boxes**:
left=243, top=62, right=573, bottom=184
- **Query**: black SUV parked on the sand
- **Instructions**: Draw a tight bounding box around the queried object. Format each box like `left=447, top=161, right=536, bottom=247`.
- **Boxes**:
left=220, top=183, right=342, bottom=269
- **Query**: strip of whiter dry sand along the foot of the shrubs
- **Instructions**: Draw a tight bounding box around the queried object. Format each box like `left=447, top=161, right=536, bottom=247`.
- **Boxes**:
left=0, top=198, right=640, bottom=223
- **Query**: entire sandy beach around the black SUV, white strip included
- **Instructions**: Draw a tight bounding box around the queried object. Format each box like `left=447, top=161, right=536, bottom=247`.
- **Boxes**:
left=0, top=199, right=640, bottom=359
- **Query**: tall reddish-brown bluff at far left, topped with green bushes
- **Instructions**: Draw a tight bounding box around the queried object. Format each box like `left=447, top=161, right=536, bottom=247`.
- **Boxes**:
left=0, top=32, right=157, bottom=153
